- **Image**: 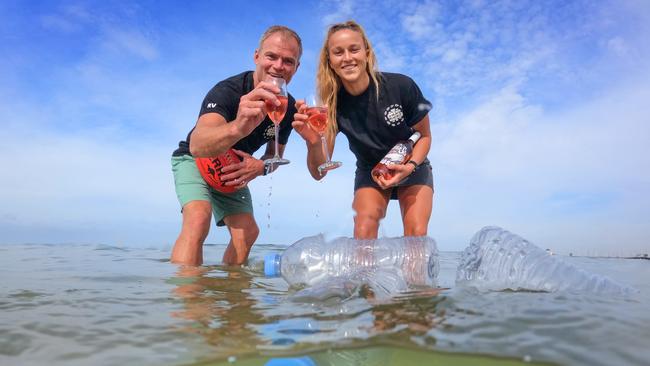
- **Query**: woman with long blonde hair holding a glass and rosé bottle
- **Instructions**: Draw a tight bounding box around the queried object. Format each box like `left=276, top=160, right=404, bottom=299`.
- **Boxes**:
left=293, top=21, right=433, bottom=239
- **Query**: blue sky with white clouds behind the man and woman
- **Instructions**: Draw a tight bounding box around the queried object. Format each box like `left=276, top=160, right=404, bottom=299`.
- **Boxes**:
left=0, top=0, right=650, bottom=262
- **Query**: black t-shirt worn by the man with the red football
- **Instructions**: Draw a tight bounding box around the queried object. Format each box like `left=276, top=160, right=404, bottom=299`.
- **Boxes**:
left=172, top=71, right=296, bottom=156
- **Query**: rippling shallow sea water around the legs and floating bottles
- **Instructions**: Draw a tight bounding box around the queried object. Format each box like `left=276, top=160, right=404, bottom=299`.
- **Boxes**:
left=0, top=244, right=650, bottom=365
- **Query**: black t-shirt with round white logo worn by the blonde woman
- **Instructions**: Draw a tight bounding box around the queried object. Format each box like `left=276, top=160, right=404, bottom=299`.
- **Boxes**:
left=336, top=73, right=431, bottom=170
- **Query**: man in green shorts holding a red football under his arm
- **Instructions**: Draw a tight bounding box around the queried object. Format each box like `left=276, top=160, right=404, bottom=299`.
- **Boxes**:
left=171, top=26, right=302, bottom=265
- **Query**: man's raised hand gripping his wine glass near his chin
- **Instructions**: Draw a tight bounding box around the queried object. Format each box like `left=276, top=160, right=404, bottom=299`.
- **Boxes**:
left=234, top=81, right=280, bottom=136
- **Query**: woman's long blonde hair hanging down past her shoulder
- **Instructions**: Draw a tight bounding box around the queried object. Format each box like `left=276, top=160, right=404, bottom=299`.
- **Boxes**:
left=316, top=20, right=379, bottom=146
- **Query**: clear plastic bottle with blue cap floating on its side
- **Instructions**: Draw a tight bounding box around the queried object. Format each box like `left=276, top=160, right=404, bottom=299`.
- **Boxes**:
left=264, top=235, right=439, bottom=291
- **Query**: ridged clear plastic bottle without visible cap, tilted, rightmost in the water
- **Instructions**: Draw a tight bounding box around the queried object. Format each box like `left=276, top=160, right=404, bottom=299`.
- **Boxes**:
left=456, top=226, right=635, bottom=293
